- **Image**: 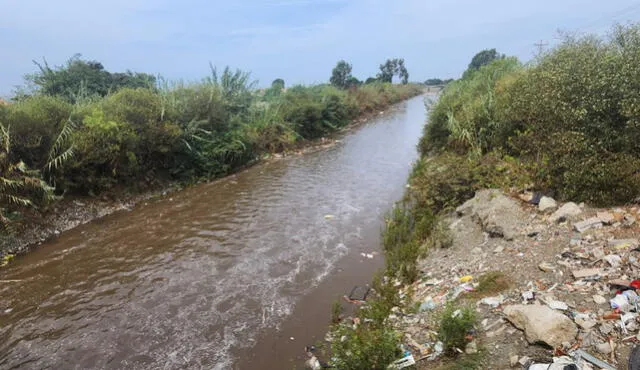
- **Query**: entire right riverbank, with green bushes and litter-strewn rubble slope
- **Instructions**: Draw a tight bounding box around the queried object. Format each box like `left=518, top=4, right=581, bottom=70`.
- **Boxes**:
left=330, top=25, right=640, bottom=369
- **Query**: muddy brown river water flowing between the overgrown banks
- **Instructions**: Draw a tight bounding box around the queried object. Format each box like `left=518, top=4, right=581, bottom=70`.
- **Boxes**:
left=0, top=97, right=425, bottom=369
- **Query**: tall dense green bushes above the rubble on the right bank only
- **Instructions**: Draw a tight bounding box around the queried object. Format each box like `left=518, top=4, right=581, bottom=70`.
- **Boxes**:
left=428, top=25, right=640, bottom=205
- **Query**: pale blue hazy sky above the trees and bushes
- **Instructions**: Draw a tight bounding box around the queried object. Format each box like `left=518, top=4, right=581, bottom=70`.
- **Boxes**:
left=0, top=0, right=640, bottom=97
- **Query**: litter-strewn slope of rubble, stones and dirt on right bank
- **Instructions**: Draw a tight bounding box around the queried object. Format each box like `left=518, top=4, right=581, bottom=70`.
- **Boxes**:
left=364, top=190, right=640, bottom=369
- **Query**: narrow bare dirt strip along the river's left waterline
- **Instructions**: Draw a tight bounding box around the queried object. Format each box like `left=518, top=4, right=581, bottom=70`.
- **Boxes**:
left=0, top=92, right=420, bottom=262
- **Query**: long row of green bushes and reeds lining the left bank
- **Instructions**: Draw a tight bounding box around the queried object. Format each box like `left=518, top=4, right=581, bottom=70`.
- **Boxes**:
left=0, top=56, right=421, bottom=237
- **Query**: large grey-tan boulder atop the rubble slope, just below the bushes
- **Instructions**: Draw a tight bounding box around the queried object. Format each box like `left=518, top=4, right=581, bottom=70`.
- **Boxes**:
left=456, top=189, right=525, bottom=240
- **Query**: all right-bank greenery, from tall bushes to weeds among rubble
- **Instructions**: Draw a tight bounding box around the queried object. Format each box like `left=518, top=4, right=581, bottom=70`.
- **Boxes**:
left=332, top=25, right=640, bottom=369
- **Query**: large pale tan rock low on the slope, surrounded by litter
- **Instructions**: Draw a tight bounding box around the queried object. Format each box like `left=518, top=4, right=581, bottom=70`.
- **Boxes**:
left=504, top=305, right=578, bottom=348
